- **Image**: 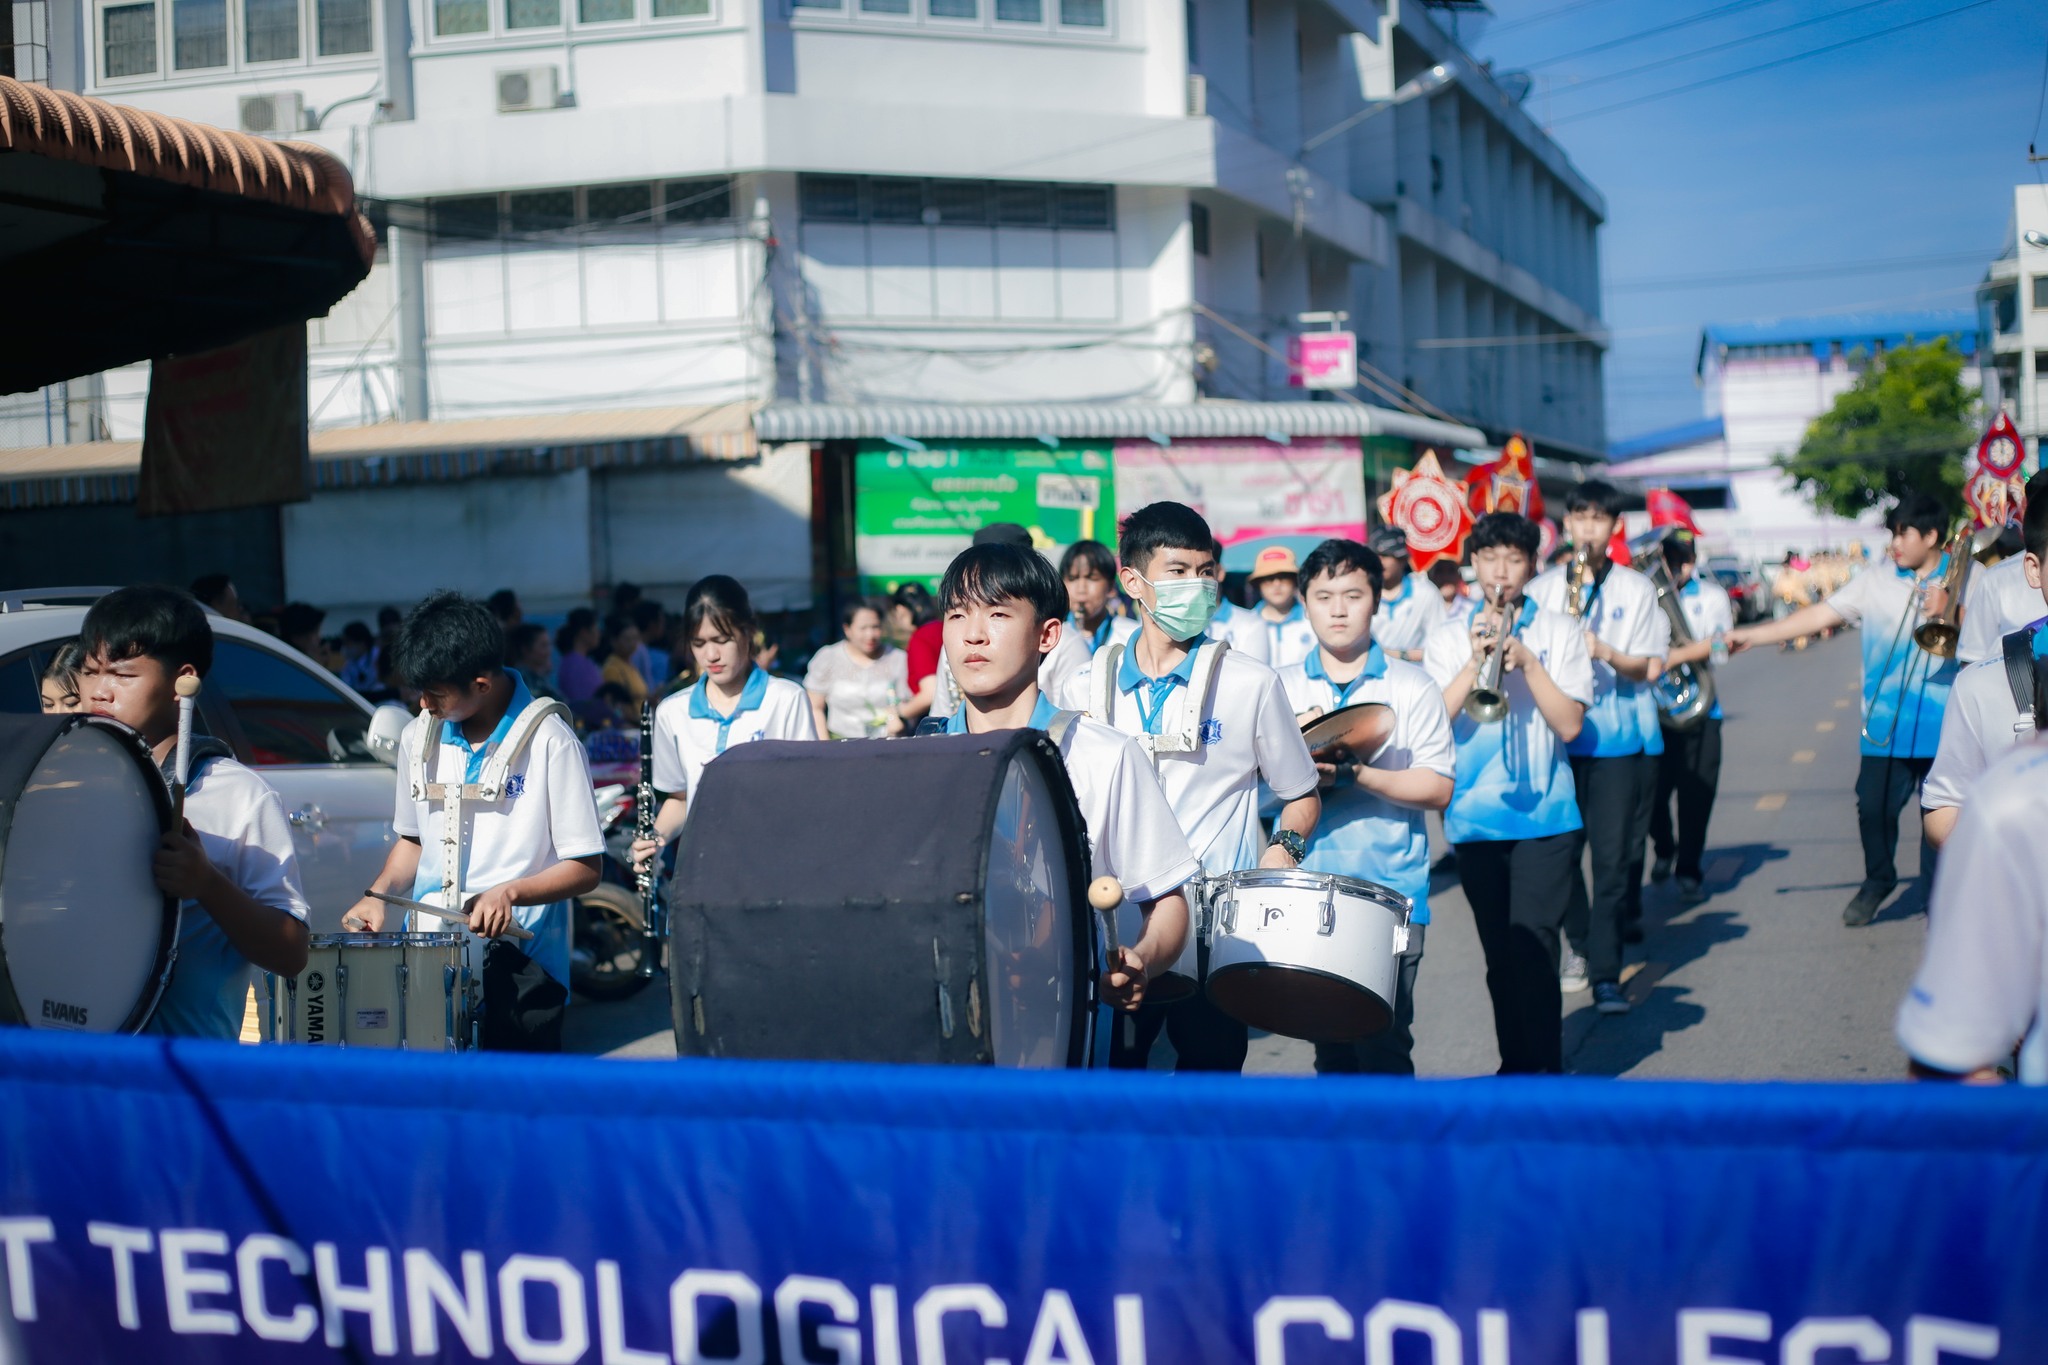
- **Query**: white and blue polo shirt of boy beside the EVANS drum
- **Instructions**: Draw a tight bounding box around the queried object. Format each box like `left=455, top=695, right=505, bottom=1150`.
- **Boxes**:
left=147, top=757, right=307, bottom=1042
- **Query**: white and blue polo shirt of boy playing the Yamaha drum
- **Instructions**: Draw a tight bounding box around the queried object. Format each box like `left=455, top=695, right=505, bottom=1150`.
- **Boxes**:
left=391, top=684, right=604, bottom=986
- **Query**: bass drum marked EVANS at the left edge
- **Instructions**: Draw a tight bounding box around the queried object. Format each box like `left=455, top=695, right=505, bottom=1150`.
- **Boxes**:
left=0, top=716, right=178, bottom=1033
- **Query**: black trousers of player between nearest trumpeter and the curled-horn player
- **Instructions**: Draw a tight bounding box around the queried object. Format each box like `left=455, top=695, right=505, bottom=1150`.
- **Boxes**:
left=1565, top=753, right=1657, bottom=984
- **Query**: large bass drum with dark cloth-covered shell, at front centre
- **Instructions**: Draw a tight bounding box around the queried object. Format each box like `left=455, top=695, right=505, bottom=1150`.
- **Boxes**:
left=670, top=731, right=1098, bottom=1066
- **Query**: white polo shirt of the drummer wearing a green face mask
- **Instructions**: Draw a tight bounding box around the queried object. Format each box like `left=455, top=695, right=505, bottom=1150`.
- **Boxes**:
left=1057, top=645, right=1315, bottom=876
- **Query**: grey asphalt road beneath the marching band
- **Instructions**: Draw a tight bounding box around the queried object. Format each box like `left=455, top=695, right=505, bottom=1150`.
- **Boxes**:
left=569, top=632, right=1925, bottom=1081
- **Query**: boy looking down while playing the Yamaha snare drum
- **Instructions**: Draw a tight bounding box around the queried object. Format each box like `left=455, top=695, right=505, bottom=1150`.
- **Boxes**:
left=344, top=591, right=604, bottom=1052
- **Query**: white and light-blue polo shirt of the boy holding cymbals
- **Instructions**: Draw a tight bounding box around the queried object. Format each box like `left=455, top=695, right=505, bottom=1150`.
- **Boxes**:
left=1280, top=643, right=1458, bottom=925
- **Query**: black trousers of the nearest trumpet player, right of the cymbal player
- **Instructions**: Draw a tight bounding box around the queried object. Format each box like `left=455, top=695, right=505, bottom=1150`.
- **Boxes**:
left=1456, top=833, right=1579, bottom=1074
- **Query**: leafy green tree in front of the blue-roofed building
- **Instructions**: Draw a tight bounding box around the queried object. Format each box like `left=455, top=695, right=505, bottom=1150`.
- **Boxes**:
left=1774, top=338, right=1976, bottom=516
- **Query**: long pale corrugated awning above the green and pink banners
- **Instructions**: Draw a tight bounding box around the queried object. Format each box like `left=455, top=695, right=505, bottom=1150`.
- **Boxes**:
left=754, top=401, right=1487, bottom=446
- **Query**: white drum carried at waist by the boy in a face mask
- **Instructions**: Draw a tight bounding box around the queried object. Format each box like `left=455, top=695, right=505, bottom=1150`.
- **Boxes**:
left=1206, top=870, right=1413, bottom=1042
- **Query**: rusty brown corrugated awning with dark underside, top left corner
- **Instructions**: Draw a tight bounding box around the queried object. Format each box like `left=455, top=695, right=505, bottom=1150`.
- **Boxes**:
left=0, top=76, right=377, bottom=393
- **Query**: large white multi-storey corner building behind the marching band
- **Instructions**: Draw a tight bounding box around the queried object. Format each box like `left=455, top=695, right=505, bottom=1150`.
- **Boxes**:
left=0, top=0, right=1606, bottom=604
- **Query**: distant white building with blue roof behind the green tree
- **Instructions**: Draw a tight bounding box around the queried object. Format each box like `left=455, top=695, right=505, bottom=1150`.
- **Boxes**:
left=1608, top=309, right=1985, bottom=561
